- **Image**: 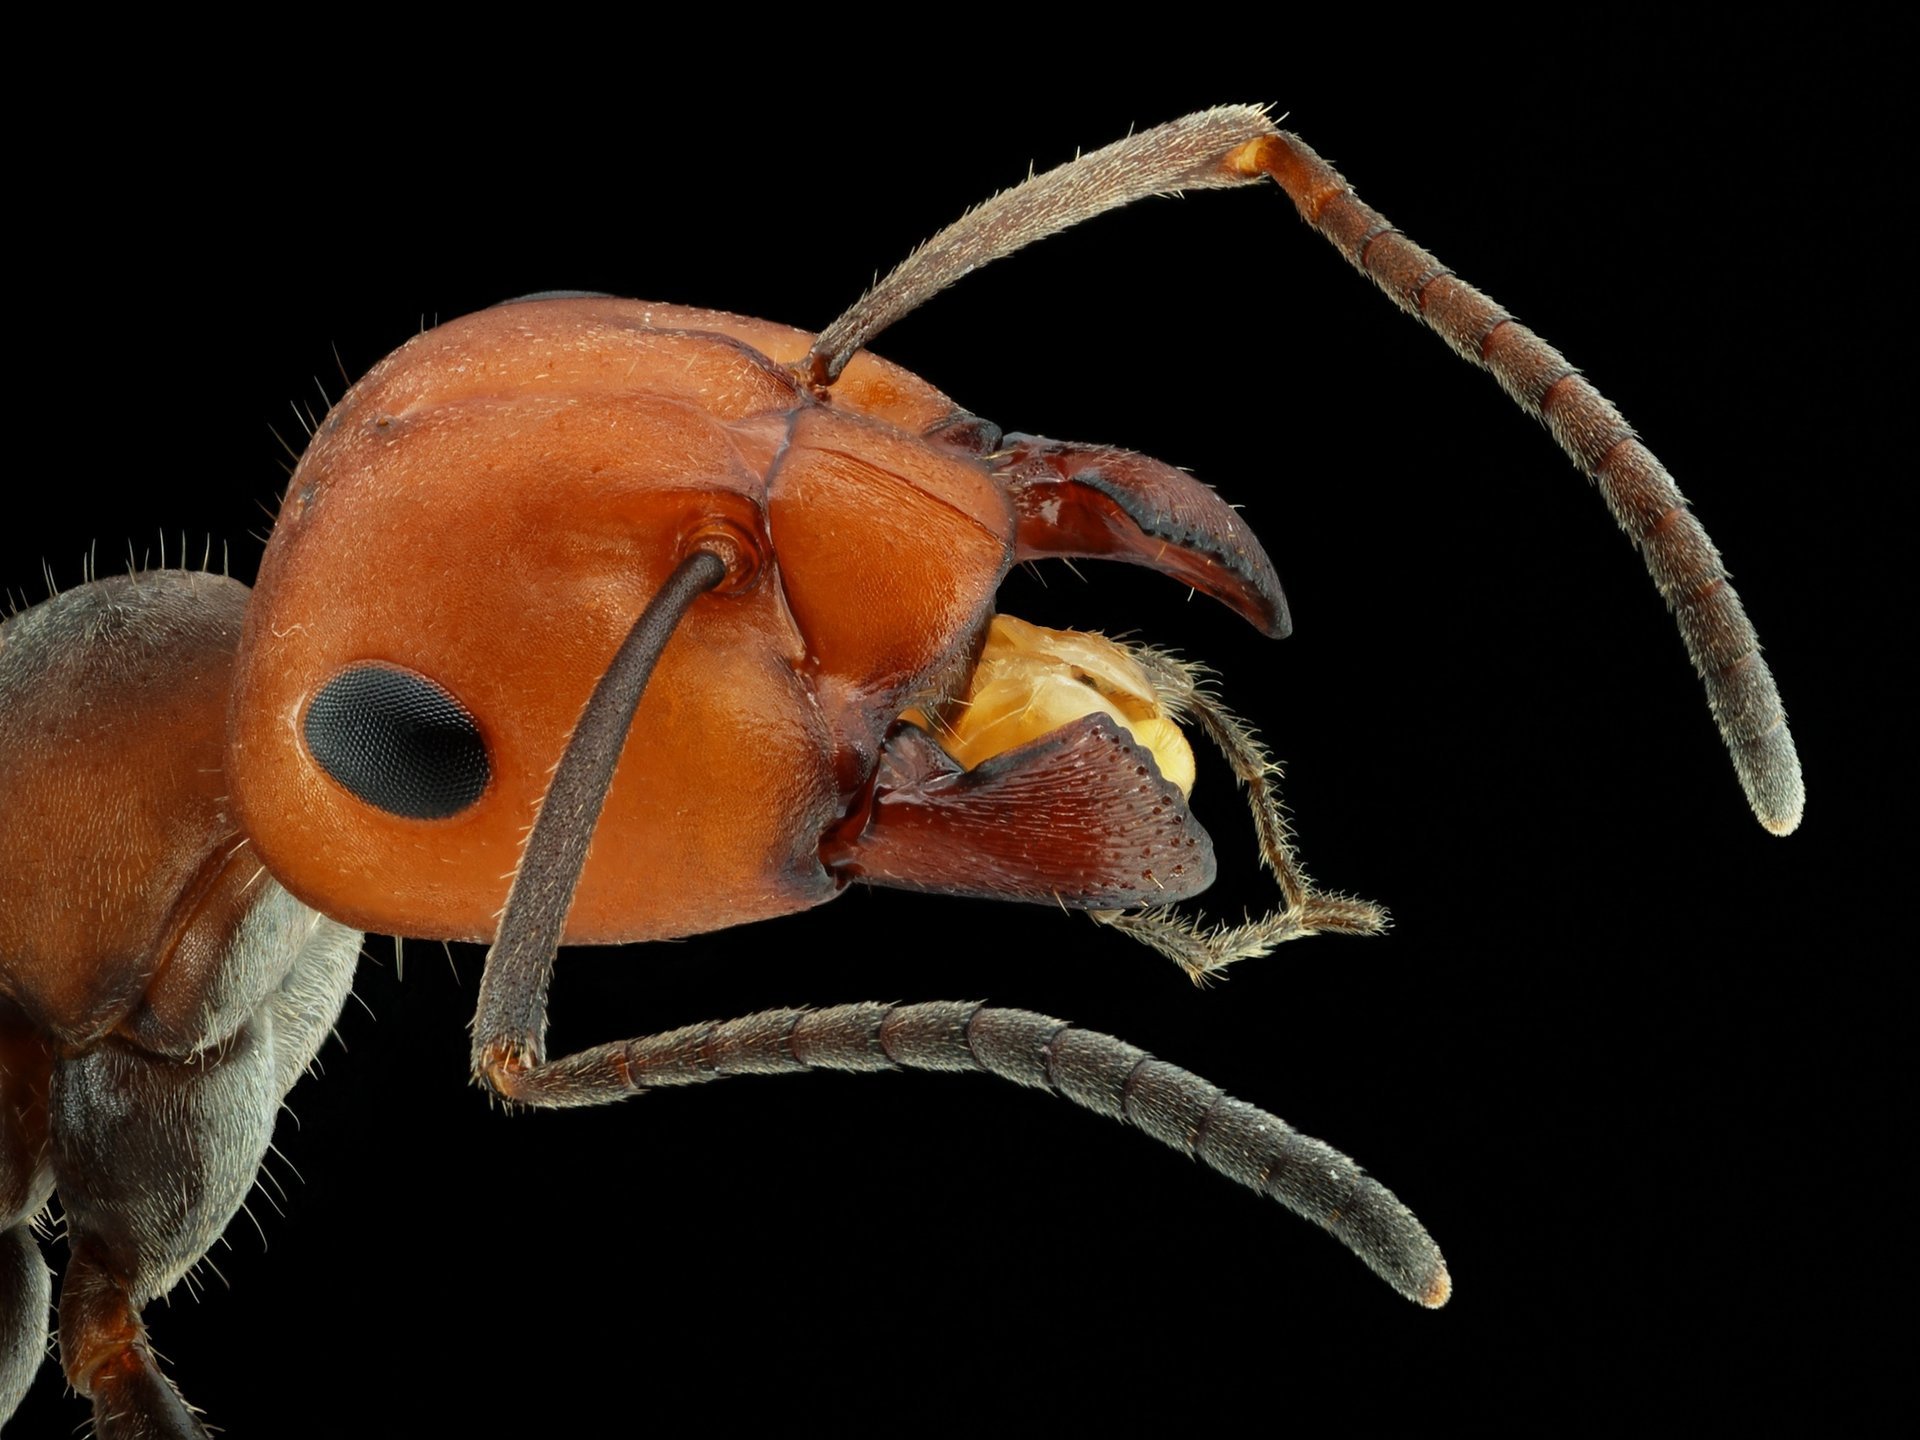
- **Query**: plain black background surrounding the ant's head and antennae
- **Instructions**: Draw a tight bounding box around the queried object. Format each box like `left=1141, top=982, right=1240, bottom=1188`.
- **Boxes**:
left=0, top=36, right=1912, bottom=1436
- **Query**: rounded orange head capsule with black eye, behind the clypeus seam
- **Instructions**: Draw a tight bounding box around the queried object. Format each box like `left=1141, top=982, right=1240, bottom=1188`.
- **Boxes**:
left=228, top=300, right=835, bottom=941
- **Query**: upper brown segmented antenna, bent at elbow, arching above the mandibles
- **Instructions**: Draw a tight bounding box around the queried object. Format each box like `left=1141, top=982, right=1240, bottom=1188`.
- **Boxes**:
left=795, top=106, right=1807, bottom=835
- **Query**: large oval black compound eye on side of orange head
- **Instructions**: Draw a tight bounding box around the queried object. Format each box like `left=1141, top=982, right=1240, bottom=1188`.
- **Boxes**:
left=305, top=664, right=492, bottom=820
